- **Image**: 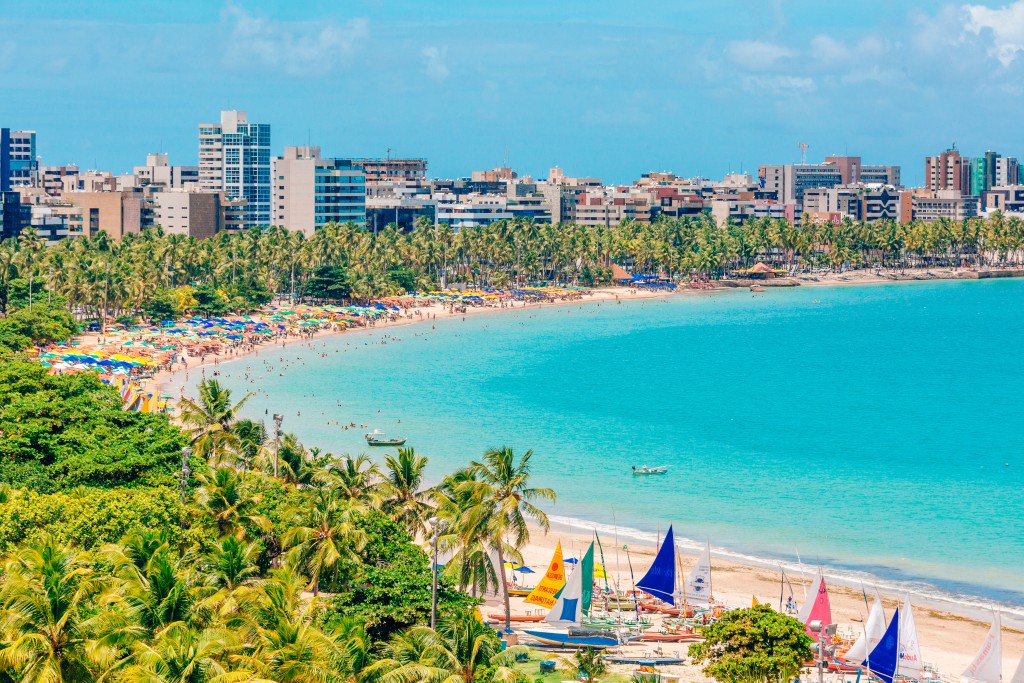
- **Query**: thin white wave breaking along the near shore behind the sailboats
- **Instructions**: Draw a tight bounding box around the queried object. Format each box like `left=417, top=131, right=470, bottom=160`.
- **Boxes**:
left=548, top=515, right=1024, bottom=628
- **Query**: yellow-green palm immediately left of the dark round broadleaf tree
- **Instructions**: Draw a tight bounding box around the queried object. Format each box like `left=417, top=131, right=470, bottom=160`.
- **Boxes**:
left=283, top=486, right=367, bottom=596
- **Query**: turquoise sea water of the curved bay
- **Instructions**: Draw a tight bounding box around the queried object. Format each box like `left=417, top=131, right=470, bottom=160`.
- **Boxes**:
left=182, top=281, right=1024, bottom=606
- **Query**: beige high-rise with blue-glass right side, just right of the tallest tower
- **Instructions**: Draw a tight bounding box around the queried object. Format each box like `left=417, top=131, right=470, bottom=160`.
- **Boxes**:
left=273, top=146, right=367, bottom=234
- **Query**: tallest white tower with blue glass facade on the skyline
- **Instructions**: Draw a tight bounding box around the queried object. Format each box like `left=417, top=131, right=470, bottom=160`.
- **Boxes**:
left=199, top=112, right=271, bottom=227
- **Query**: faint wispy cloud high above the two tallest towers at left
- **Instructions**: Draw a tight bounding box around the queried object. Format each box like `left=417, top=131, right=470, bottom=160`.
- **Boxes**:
left=221, top=0, right=370, bottom=76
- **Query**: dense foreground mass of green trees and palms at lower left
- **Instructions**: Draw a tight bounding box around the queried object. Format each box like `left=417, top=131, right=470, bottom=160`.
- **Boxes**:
left=0, top=374, right=544, bottom=683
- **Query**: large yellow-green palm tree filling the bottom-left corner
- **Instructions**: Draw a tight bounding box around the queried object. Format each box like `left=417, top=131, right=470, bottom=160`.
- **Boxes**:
left=0, top=537, right=133, bottom=683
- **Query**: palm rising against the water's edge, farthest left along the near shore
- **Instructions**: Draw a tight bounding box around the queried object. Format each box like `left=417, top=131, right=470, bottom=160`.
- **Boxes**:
left=179, top=380, right=252, bottom=464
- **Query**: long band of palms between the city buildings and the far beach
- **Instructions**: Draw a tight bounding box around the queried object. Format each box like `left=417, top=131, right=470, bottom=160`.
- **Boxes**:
left=0, top=212, right=1024, bottom=319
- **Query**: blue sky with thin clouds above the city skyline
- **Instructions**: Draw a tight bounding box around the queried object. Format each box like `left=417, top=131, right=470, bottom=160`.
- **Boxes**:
left=0, top=0, right=1024, bottom=182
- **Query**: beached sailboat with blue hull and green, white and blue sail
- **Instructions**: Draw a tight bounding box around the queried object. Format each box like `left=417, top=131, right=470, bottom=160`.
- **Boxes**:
left=523, top=543, right=618, bottom=649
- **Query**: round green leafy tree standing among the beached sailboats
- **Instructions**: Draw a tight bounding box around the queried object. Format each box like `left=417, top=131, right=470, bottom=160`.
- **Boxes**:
left=690, top=605, right=814, bottom=683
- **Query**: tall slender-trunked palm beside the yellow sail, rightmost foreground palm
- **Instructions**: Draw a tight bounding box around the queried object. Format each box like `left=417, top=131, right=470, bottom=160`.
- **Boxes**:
left=462, top=446, right=555, bottom=631
